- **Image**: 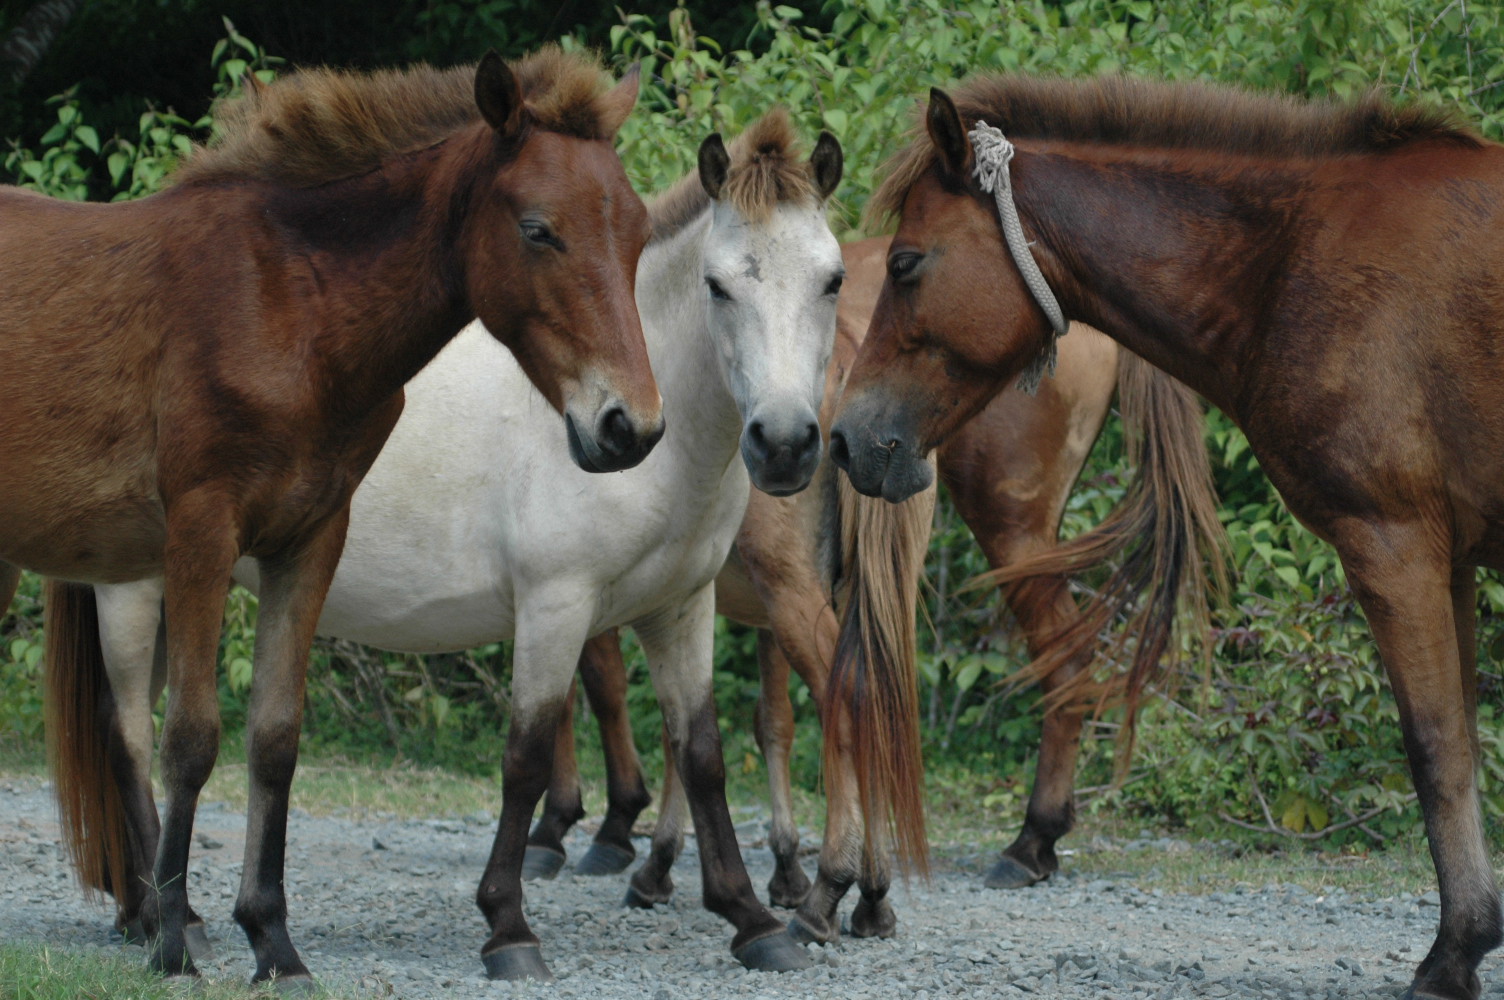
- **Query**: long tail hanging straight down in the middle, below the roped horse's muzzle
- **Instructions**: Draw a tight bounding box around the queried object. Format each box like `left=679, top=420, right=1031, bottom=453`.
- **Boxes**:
left=823, top=475, right=935, bottom=874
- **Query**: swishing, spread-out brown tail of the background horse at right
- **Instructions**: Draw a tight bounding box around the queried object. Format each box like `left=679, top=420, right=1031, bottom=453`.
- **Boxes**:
left=985, top=350, right=1227, bottom=751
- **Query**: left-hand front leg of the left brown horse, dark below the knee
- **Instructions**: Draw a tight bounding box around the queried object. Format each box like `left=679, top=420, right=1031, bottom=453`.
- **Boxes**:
left=141, top=492, right=238, bottom=974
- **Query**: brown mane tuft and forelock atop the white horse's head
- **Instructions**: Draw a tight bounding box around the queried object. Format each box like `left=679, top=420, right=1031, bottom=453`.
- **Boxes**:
left=648, top=108, right=820, bottom=239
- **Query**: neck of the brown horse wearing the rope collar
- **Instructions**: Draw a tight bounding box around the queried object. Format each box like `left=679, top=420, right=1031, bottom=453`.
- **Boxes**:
left=1012, top=142, right=1301, bottom=409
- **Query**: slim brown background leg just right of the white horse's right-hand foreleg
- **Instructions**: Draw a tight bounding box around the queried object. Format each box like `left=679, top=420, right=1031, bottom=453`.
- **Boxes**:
left=755, top=629, right=809, bottom=908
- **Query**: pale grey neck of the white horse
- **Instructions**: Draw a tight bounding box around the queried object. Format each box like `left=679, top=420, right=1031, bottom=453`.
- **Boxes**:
left=636, top=209, right=741, bottom=466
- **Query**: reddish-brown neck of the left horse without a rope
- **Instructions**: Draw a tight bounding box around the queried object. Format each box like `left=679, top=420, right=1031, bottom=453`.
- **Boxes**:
left=249, top=138, right=472, bottom=414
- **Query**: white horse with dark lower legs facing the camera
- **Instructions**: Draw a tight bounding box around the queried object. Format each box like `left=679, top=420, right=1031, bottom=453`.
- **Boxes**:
left=47, top=111, right=844, bottom=979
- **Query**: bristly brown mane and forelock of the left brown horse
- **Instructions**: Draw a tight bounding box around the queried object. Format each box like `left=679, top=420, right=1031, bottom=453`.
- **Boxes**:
left=171, top=45, right=611, bottom=188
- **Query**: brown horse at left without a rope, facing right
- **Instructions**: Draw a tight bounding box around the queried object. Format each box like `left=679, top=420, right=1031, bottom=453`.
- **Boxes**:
left=0, top=50, right=663, bottom=979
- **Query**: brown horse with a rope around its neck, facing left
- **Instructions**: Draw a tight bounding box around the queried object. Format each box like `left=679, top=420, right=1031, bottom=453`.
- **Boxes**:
left=832, top=77, right=1504, bottom=998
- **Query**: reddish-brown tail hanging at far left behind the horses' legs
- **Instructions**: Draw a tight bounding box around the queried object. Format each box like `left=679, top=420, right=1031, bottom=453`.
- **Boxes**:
left=42, top=580, right=126, bottom=899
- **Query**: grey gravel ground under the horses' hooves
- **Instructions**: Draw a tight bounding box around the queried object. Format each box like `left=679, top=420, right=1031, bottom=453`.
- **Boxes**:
left=0, top=779, right=1504, bottom=1000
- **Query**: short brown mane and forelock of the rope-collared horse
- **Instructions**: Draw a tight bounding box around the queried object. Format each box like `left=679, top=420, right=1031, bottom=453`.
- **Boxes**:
left=866, top=74, right=1481, bottom=221
